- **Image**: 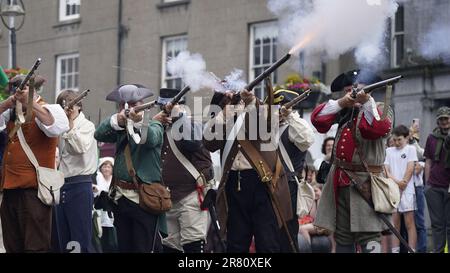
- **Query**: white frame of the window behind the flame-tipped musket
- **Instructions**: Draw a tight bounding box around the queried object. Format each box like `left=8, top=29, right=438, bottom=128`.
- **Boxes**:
left=248, top=21, right=278, bottom=99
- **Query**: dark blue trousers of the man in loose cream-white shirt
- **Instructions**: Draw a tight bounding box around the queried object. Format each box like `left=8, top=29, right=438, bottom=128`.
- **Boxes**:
left=53, top=175, right=94, bottom=253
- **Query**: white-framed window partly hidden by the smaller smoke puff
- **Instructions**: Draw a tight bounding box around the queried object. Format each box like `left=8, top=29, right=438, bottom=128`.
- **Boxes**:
left=161, top=35, right=187, bottom=89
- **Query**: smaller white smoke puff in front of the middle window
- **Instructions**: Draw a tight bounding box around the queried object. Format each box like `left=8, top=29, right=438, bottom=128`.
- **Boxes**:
left=167, top=51, right=220, bottom=92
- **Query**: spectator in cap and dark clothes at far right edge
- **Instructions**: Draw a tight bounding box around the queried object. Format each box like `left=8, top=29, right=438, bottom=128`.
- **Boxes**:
left=424, top=106, right=450, bottom=253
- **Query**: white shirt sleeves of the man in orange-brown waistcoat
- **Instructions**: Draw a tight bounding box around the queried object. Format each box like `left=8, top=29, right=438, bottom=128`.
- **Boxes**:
left=0, top=97, right=69, bottom=137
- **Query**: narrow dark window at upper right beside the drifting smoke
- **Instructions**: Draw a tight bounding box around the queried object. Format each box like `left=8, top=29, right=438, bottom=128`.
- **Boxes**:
left=391, top=6, right=405, bottom=67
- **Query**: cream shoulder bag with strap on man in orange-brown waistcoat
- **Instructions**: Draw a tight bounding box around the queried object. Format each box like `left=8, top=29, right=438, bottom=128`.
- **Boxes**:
left=17, top=128, right=64, bottom=206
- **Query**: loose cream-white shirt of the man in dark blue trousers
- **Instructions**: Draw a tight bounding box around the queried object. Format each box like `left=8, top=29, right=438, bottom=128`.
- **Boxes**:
left=59, top=112, right=98, bottom=178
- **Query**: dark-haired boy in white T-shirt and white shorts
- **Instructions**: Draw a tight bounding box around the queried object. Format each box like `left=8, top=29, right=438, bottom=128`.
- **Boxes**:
left=384, top=125, right=417, bottom=253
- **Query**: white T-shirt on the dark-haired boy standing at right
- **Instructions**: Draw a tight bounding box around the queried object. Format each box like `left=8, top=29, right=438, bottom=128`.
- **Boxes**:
left=384, top=145, right=417, bottom=194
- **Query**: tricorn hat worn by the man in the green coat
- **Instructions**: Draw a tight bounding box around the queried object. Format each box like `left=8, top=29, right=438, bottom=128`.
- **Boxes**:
left=106, top=84, right=153, bottom=103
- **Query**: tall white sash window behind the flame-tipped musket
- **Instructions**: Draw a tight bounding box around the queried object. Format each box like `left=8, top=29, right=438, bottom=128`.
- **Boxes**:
left=249, top=22, right=278, bottom=99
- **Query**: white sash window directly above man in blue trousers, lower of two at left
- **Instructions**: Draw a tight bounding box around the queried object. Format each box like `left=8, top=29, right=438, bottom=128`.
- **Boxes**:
left=56, top=53, right=80, bottom=95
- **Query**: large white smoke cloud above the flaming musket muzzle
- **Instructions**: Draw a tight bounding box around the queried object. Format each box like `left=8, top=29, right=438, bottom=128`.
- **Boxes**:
left=268, top=0, right=398, bottom=65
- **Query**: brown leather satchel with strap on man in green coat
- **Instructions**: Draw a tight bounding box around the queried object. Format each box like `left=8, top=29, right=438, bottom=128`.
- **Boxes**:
left=124, top=144, right=172, bottom=214
